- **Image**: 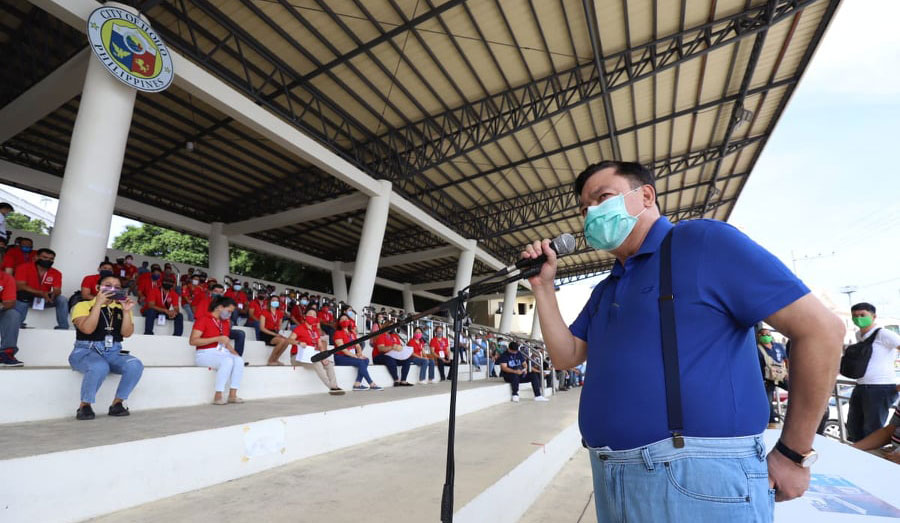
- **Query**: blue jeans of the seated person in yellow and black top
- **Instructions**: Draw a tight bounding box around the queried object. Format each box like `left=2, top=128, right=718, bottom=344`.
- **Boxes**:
left=69, top=341, right=144, bottom=403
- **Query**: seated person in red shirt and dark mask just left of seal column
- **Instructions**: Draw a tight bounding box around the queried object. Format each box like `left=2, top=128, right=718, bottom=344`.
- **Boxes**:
left=16, top=249, right=69, bottom=330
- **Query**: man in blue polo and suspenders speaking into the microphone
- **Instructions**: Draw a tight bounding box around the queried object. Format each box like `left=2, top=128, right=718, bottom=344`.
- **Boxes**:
left=523, top=161, right=844, bottom=522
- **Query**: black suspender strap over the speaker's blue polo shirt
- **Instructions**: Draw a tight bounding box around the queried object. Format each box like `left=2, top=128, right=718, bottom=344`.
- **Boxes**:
left=659, top=229, right=684, bottom=449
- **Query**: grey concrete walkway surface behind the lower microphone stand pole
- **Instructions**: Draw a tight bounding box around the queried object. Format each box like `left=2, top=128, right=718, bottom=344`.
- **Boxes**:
left=82, top=392, right=579, bottom=523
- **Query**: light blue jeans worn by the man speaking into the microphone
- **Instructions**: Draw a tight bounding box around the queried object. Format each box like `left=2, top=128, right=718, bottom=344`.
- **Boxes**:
left=588, top=436, right=775, bottom=523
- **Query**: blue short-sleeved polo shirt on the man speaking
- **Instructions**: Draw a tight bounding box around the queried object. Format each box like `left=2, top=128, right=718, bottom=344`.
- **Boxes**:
left=569, top=218, right=809, bottom=450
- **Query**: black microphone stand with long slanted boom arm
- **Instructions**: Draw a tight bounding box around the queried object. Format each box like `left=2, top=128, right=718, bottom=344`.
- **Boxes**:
left=311, top=265, right=541, bottom=523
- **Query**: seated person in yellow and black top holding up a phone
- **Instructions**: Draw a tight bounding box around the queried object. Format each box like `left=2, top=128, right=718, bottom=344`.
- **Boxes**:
left=68, top=274, right=144, bottom=420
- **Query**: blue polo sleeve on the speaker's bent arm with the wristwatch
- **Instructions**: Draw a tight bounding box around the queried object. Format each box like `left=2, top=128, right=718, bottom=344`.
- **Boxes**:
left=696, top=220, right=809, bottom=328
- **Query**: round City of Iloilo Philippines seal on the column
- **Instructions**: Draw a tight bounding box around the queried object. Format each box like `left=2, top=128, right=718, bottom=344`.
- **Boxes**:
left=87, top=7, right=175, bottom=93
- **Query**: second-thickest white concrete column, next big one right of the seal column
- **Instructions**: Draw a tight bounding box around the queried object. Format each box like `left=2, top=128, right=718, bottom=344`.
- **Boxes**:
left=348, top=180, right=391, bottom=322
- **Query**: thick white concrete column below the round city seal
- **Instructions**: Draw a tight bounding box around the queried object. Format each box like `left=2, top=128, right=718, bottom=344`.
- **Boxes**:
left=50, top=31, right=136, bottom=296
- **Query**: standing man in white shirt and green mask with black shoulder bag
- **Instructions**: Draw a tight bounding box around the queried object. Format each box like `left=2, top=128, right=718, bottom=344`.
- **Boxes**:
left=848, top=302, right=900, bottom=443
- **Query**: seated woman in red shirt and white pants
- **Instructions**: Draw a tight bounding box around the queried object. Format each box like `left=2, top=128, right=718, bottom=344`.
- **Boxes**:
left=189, top=294, right=245, bottom=405
